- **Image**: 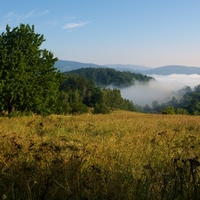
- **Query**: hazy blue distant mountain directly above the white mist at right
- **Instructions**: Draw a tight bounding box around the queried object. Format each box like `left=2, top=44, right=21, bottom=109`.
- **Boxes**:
left=141, top=65, right=200, bottom=75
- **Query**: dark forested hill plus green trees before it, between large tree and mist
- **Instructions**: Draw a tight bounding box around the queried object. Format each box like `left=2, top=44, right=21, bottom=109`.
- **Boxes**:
left=60, top=68, right=154, bottom=114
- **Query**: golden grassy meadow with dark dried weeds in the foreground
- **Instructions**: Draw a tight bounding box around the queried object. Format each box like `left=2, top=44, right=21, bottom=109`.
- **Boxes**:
left=0, top=111, right=200, bottom=200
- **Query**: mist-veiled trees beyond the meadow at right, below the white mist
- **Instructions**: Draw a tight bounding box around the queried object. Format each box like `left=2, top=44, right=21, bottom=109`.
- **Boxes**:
left=139, top=84, right=200, bottom=115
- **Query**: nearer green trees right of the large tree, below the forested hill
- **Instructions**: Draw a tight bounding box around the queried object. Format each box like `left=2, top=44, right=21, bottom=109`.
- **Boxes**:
left=59, top=74, right=135, bottom=114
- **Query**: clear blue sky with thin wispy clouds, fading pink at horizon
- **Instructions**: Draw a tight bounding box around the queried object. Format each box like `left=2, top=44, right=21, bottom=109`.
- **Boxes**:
left=0, top=0, right=200, bottom=67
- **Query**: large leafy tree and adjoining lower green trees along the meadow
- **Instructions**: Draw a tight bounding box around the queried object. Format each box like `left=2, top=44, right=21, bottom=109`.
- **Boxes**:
left=0, top=24, right=135, bottom=115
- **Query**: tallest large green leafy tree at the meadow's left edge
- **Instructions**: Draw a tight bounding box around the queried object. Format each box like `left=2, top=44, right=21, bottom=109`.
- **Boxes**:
left=0, top=24, right=62, bottom=114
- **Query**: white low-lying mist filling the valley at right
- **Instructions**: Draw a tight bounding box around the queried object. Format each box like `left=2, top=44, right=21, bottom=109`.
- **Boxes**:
left=120, top=74, right=200, bottom=106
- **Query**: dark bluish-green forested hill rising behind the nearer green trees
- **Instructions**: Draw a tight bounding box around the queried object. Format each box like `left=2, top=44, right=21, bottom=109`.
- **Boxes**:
left=64, top=68, right=154, bottom=87
